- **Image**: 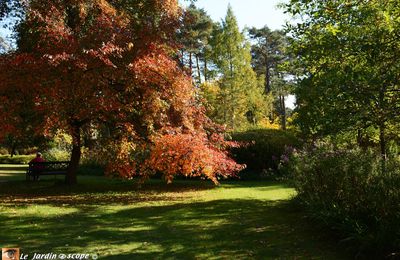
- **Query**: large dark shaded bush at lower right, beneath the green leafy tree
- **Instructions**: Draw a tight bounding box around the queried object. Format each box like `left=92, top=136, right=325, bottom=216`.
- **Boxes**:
left=288, top=144, right=400, bottom=257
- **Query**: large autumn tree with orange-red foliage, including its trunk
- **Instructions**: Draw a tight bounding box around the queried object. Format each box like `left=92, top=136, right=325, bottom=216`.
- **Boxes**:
left=0, top=0, right=242, bottom=184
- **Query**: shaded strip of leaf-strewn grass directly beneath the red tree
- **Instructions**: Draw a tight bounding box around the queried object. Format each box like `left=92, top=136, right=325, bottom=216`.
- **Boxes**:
left=0, top=177, right=216, bottom=205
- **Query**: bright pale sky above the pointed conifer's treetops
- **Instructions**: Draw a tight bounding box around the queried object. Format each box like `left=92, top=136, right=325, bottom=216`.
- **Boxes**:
left=179, top=0, right=289, bottom=30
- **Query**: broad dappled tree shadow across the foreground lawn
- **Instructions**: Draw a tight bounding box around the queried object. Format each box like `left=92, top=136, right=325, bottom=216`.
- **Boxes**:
left=0, top=199, right=347, bottom=259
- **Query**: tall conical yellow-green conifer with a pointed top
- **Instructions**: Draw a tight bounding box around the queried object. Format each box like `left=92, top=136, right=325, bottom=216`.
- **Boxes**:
left=206, top=6, right=265, bottom=129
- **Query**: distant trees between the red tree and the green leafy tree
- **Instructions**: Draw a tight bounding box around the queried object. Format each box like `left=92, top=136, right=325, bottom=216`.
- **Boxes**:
left=178, top=4, right=294, bottom=131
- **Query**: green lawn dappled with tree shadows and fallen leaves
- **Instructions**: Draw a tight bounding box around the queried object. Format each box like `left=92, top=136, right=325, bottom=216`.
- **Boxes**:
left=0, top=166, right=349, bottom=259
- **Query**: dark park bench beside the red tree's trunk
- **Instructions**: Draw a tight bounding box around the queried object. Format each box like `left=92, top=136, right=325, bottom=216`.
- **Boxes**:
left=26, top=161, right=70, bottom=181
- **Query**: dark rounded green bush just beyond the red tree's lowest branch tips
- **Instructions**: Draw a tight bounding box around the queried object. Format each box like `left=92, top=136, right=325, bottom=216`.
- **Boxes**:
left=231, top=129, right=300, bottom=178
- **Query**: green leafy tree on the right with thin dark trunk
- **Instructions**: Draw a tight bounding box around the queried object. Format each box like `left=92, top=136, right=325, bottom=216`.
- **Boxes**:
left=286, top=0, right=400, bottom=161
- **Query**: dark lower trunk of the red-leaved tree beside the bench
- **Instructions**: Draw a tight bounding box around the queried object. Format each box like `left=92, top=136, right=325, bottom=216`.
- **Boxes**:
left=65, top=125, right=81, bottom=185
